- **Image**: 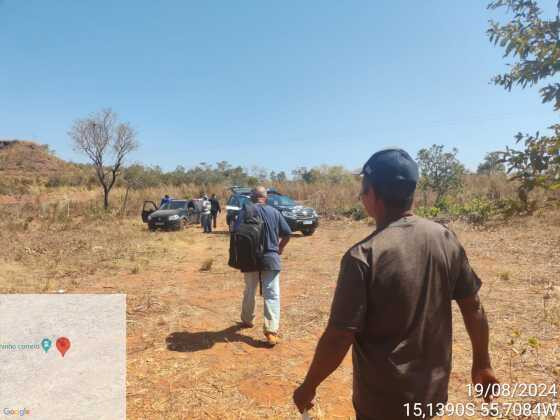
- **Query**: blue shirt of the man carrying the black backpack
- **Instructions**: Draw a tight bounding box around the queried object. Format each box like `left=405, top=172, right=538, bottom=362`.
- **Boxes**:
left=234, top=204, right=292, bottom=271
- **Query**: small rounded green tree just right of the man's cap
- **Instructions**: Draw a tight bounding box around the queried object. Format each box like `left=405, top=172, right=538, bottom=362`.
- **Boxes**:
left=416, top=144, right=465, bottom=205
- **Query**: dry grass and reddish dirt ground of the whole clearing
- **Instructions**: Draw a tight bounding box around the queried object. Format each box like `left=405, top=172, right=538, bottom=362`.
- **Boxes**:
left=0, top=204, right=560, bottom=419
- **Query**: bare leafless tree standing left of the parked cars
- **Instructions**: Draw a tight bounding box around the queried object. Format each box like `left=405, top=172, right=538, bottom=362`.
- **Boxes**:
left=68, top=109, right=139, bottom=209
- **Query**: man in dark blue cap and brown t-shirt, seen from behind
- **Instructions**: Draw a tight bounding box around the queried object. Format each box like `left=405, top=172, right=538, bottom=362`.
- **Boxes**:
left=294, top=149, right=497, bottom=420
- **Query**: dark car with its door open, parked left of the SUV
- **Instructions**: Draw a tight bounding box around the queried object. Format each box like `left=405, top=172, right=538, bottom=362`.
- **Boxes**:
left=142, top=200, right=192, bottom=230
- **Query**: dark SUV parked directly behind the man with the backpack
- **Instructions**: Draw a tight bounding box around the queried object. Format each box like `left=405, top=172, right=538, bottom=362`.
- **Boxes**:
left=226, top=187, right=319, bottom=236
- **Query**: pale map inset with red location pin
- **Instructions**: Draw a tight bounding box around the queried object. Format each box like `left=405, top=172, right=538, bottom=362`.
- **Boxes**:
left=0, top=294, right=126, bottom=420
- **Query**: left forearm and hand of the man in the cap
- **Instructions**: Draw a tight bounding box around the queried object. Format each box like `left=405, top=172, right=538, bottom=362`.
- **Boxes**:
left=294, top=325, right=354, bottom=413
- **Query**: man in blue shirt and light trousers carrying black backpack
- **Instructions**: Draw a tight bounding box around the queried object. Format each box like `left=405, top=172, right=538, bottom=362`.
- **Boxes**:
left=229, top=186, right=292, bottom=347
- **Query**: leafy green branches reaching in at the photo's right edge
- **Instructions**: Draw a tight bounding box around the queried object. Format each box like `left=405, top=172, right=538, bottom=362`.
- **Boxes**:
left=487, top=0, right=560, bottom=203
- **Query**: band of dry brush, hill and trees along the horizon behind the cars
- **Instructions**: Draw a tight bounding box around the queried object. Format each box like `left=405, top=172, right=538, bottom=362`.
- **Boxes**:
left=0, top=140, right=560, bottom=226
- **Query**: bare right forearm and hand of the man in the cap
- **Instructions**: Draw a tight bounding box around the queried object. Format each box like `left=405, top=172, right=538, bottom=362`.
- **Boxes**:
left=457, top=293, right=499, bottom=402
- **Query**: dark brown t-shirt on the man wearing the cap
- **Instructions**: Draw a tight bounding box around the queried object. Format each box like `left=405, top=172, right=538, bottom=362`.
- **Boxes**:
left=329, top=216, right=481, bottom=420
